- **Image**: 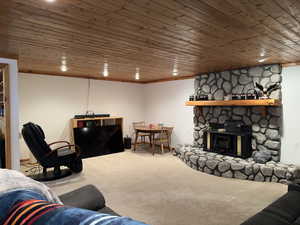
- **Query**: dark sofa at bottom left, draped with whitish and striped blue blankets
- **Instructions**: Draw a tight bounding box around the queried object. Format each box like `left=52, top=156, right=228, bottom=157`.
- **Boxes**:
left=0, top=169, right=145, bottom=225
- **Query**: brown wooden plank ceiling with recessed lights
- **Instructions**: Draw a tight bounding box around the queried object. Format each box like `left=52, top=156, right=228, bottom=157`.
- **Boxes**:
left=0, top=0, right=300, bottom=82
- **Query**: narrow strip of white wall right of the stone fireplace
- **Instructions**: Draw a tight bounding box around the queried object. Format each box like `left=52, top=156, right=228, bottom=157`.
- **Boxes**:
left=281, top=66, right=300, bottom=165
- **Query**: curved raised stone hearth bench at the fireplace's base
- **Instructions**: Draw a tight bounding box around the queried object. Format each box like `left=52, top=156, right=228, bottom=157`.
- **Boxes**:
left=174, top=145, right=300, bottom=184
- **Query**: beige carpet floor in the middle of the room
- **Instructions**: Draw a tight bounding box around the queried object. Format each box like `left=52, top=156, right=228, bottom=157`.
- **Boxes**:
left=48, top=150, right=287, bottom=225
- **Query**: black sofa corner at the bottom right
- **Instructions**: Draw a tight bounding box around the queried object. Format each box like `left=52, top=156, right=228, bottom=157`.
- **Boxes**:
left=241, top=184, right=300, bottom=225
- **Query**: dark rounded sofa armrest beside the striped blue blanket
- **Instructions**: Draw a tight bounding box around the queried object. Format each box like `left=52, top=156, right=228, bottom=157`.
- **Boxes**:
left=59, top=185, right=105, bottom=211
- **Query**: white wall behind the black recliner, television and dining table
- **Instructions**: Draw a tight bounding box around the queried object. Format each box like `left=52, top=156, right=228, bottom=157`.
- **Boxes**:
left=19, top=73, right=194, bottom=158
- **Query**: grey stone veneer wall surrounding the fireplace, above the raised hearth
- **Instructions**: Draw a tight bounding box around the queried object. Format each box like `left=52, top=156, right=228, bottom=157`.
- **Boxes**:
left=194, top=64, right=282, bottom=162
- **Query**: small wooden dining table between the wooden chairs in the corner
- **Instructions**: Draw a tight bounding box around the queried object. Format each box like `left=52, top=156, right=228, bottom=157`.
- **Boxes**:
left=133, top=126, right=170, bottom=155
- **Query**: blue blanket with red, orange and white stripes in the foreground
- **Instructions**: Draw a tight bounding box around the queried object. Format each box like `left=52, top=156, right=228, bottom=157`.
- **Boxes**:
left=0, top=190, right=145, bottom=225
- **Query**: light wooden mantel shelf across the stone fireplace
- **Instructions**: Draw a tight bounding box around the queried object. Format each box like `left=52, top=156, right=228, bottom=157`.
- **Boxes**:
left=185, top=99, right=281, bottom=106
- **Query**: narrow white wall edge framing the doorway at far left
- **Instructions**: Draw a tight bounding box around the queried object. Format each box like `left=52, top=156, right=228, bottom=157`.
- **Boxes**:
left=0, top=58, right=20, bottom=170
